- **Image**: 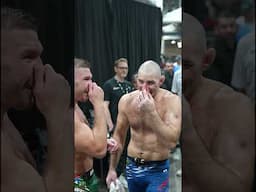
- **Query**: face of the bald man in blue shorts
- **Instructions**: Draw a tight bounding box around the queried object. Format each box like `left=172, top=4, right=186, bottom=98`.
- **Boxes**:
left=137, top=73, right=163, bottom=97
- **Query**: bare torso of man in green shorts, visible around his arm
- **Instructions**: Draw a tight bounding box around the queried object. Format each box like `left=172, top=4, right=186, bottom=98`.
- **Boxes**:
left=75, top=106, right=93, bottom=175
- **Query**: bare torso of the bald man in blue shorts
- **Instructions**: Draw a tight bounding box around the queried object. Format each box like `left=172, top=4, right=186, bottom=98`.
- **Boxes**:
left=125, top=89, right=177, bottom=161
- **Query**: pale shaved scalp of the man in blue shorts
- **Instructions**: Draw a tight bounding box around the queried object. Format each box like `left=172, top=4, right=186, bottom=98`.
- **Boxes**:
left=138, top=60, right=161, bottom=78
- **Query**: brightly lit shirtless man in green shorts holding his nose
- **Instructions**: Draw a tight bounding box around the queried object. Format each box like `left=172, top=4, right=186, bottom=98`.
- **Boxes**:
left=74, top=59, right=117, bottom=192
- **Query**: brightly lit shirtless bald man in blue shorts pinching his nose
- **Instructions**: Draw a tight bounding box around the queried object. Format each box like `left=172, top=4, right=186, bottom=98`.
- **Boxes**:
left=106, top=61, right=181, bottom=192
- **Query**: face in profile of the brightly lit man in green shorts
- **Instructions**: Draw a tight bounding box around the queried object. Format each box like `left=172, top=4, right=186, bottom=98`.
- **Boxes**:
left=75, top=67, right=92, bottom=101
